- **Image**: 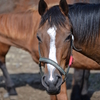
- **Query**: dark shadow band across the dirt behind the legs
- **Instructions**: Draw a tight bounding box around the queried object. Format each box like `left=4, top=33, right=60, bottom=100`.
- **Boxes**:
left=0, top=73, right=100, bottom=97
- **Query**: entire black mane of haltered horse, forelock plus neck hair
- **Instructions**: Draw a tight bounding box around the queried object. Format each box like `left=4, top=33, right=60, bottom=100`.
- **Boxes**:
left=40, top=3, right=100, bottom=44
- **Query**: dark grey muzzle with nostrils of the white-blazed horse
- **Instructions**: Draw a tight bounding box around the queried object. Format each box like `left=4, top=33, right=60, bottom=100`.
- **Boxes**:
left=42, top=74, right=63, bottom=95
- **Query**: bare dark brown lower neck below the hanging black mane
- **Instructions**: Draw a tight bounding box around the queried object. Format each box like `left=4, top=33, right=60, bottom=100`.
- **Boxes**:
left=74, top=36, right=100, bottom=64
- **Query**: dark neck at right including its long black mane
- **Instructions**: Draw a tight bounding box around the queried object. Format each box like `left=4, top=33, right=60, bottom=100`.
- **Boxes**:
left=69, top=3, right=100, bottom=63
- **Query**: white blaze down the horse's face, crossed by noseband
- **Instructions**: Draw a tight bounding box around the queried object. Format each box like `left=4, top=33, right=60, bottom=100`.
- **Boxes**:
left=47, top=26, right=57, bottom=81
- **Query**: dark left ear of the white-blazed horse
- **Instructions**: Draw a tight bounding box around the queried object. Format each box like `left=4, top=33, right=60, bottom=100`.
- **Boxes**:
left=38, top=0, right=48, bottom=16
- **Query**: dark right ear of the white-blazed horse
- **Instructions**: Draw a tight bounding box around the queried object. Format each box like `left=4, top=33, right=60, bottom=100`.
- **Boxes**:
left=59, top=0, right=68, bottom=16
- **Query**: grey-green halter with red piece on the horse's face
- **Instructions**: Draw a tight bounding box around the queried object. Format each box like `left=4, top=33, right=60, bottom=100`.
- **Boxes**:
left=39, top=34, right=79, bottom=84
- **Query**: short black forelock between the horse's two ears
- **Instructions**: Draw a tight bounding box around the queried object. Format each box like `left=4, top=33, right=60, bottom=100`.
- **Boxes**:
left=40, top=6, right=66, bottom=27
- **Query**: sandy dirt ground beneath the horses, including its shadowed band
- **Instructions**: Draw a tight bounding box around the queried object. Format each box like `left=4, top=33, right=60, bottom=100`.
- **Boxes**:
left=0, top=47, right=100, bottom=100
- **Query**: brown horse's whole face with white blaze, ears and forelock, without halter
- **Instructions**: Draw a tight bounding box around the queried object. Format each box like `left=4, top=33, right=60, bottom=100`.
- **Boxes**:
left=37, top=0, right=71, bottom=94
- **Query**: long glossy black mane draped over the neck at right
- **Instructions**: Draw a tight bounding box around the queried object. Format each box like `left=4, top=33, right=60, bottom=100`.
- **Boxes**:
left=69, top=3, right=100, bottom=44
